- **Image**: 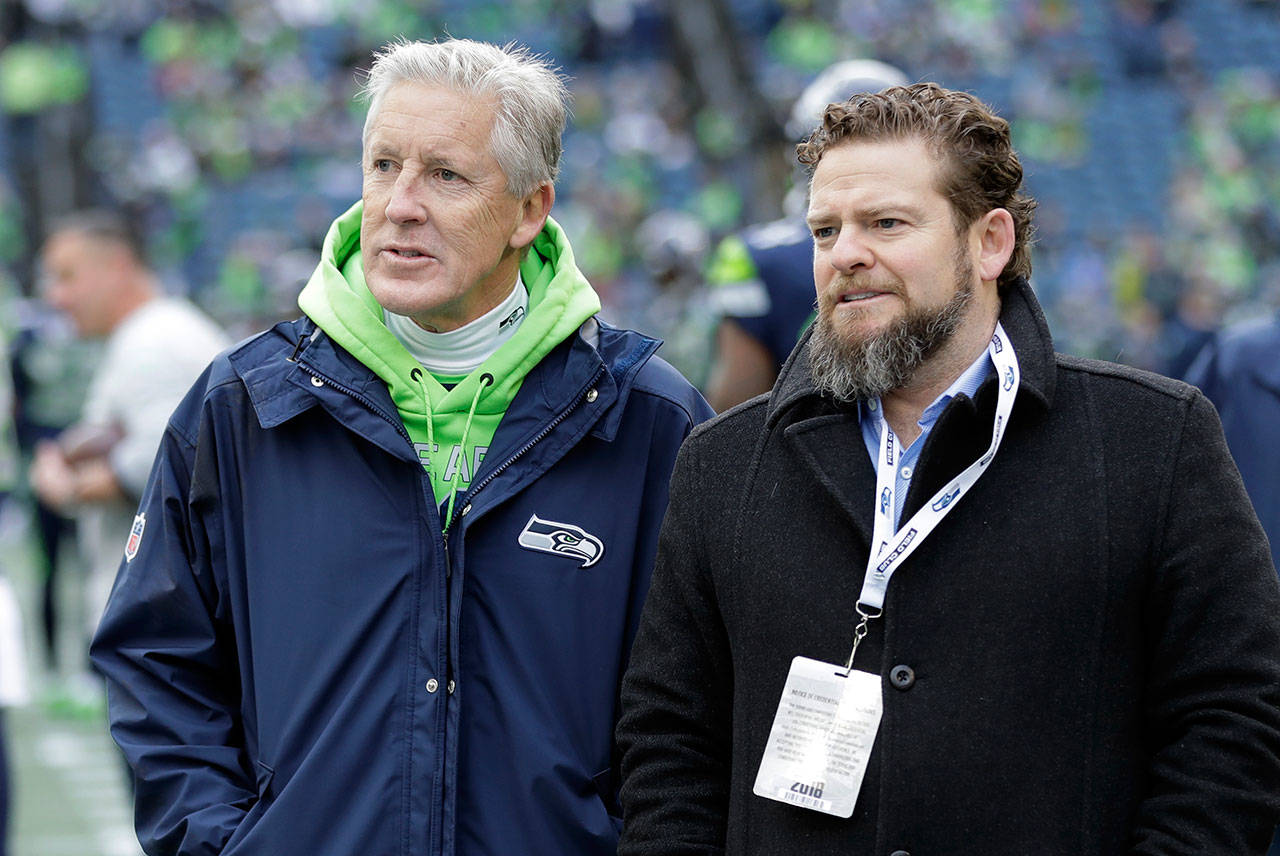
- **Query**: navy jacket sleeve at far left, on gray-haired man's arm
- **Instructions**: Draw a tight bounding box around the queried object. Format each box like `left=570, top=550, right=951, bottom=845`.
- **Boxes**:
left=91, top=409, right=257, bottom=856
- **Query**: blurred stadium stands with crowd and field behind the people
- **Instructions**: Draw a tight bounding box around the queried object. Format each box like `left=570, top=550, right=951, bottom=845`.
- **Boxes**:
left=0, top=0, right=1280, bottom=856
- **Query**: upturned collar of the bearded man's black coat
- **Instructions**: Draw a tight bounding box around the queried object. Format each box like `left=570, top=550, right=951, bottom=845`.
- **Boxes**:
left=767, top=279, right=1056, bottom=426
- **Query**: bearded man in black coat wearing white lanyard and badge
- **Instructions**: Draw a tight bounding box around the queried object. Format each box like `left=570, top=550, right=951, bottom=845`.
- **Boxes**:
left=618, top=83, right=1280, bottom=856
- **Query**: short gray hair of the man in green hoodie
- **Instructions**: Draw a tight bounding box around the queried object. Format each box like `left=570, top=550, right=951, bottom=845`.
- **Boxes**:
left=361, top=38, right=570, bottom=197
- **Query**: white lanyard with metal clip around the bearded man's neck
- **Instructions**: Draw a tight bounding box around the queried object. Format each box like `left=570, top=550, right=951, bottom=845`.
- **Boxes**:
left=845, top=322, right=1021, bottom=670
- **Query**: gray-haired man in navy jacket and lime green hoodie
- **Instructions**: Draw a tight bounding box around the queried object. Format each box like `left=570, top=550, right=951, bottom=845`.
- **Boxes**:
left=93, top=40, right=710, bottom=856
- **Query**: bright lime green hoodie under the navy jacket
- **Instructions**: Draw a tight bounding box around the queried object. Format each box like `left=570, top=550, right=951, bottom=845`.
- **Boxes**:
left=298, top=202, right=600, bottom=528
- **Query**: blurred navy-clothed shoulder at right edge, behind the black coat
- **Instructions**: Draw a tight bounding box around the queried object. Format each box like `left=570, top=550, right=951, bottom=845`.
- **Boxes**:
left=1187, top=317, right=1280, bottom=567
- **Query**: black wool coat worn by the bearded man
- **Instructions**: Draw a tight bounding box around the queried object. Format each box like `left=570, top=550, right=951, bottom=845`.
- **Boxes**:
left=617, top=277, right=1280, bottom=856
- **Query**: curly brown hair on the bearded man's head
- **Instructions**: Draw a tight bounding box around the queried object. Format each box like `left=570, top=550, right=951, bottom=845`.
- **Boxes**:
left=796, top=83, right=1036, bottom=290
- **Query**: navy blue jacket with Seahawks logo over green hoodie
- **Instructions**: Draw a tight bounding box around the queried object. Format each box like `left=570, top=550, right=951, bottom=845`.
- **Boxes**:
left=92, top=313, right=710, bottom=856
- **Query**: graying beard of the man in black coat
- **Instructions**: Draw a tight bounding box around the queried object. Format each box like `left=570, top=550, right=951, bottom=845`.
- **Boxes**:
left=809, top=265, right=973, bottom=402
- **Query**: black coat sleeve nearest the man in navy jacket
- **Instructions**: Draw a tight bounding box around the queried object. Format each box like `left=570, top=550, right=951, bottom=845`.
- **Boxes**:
left=617, top=443, right=733, bottom=856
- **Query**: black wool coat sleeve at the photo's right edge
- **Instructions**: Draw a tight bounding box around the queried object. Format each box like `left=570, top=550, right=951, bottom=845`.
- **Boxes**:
left=1133, top=394, right=1280, bottom=856
